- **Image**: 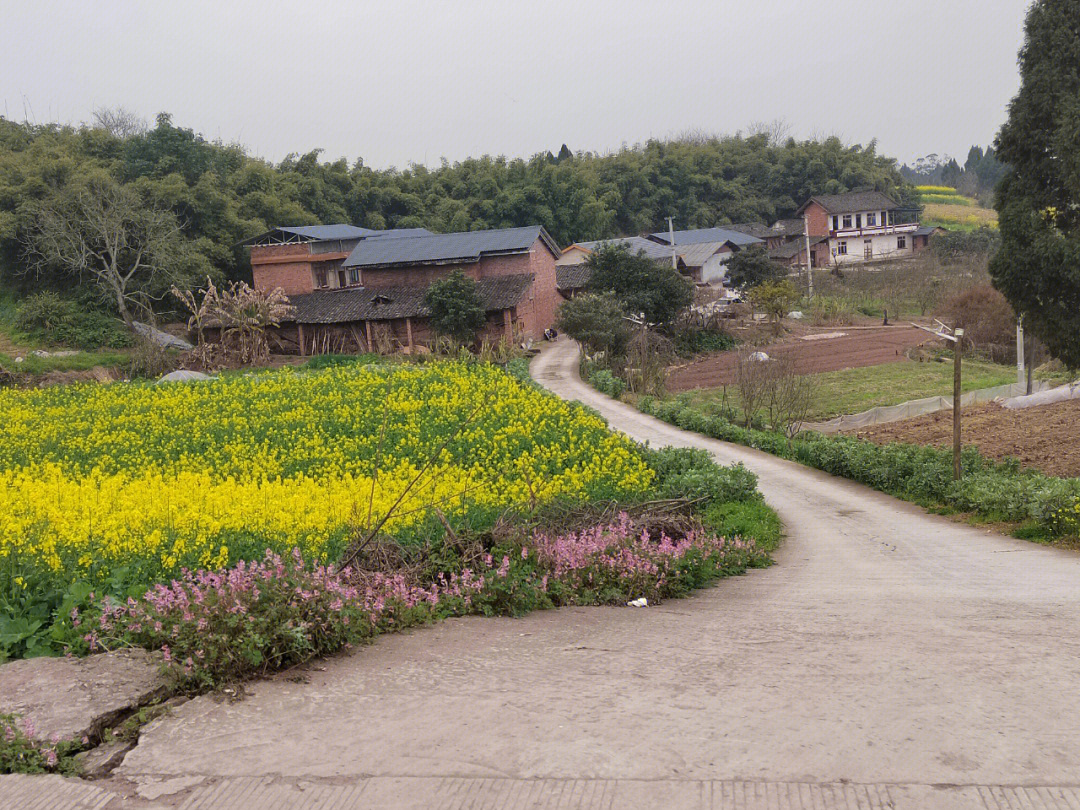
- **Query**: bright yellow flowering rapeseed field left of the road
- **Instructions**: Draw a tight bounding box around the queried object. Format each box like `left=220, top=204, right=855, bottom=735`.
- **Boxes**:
left=0, top=363, right=652, bottom=589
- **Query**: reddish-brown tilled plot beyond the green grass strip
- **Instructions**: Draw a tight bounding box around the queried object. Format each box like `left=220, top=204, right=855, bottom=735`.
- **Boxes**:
left=667, top=326, right=933, bottom=392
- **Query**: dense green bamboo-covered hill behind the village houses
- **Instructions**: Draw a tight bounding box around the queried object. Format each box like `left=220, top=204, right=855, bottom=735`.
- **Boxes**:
left=0, top=114, right=912, bottom=285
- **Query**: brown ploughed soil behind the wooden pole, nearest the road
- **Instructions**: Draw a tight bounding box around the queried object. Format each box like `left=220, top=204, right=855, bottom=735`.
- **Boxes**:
left=855, top=400, right=1080, bottom=477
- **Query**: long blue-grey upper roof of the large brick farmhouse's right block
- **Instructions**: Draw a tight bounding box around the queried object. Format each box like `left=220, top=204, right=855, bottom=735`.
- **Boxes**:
left=343, top=225, right=559, bottom=267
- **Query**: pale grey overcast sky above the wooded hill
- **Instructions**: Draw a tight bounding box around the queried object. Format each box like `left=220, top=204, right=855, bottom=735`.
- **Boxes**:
left=0, top=0, right=1028, bottom=167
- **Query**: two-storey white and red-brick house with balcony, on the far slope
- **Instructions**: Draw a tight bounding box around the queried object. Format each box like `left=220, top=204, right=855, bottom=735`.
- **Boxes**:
left=797, top=191, right=927, bottom=266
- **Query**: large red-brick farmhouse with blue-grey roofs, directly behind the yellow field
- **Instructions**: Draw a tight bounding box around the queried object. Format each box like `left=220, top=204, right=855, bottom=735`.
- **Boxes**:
left=248, top=225, right=559, bottom=354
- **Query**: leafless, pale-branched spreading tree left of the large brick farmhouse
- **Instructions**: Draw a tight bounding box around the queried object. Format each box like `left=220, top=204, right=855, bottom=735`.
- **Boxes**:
left=25, top=175, right=183, bottom=328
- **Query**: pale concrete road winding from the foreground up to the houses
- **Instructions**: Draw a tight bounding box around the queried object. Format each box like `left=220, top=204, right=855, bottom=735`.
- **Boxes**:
left=8, top=341, right=1080, bottom=810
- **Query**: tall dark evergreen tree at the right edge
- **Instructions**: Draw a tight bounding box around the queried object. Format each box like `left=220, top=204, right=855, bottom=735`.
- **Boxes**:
left=990, top=0, right=1080, bottom=367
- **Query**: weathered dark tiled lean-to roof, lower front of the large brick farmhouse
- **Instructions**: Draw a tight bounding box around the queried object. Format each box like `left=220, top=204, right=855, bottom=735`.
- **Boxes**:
left=286, top=273, right=534, bottom=324
